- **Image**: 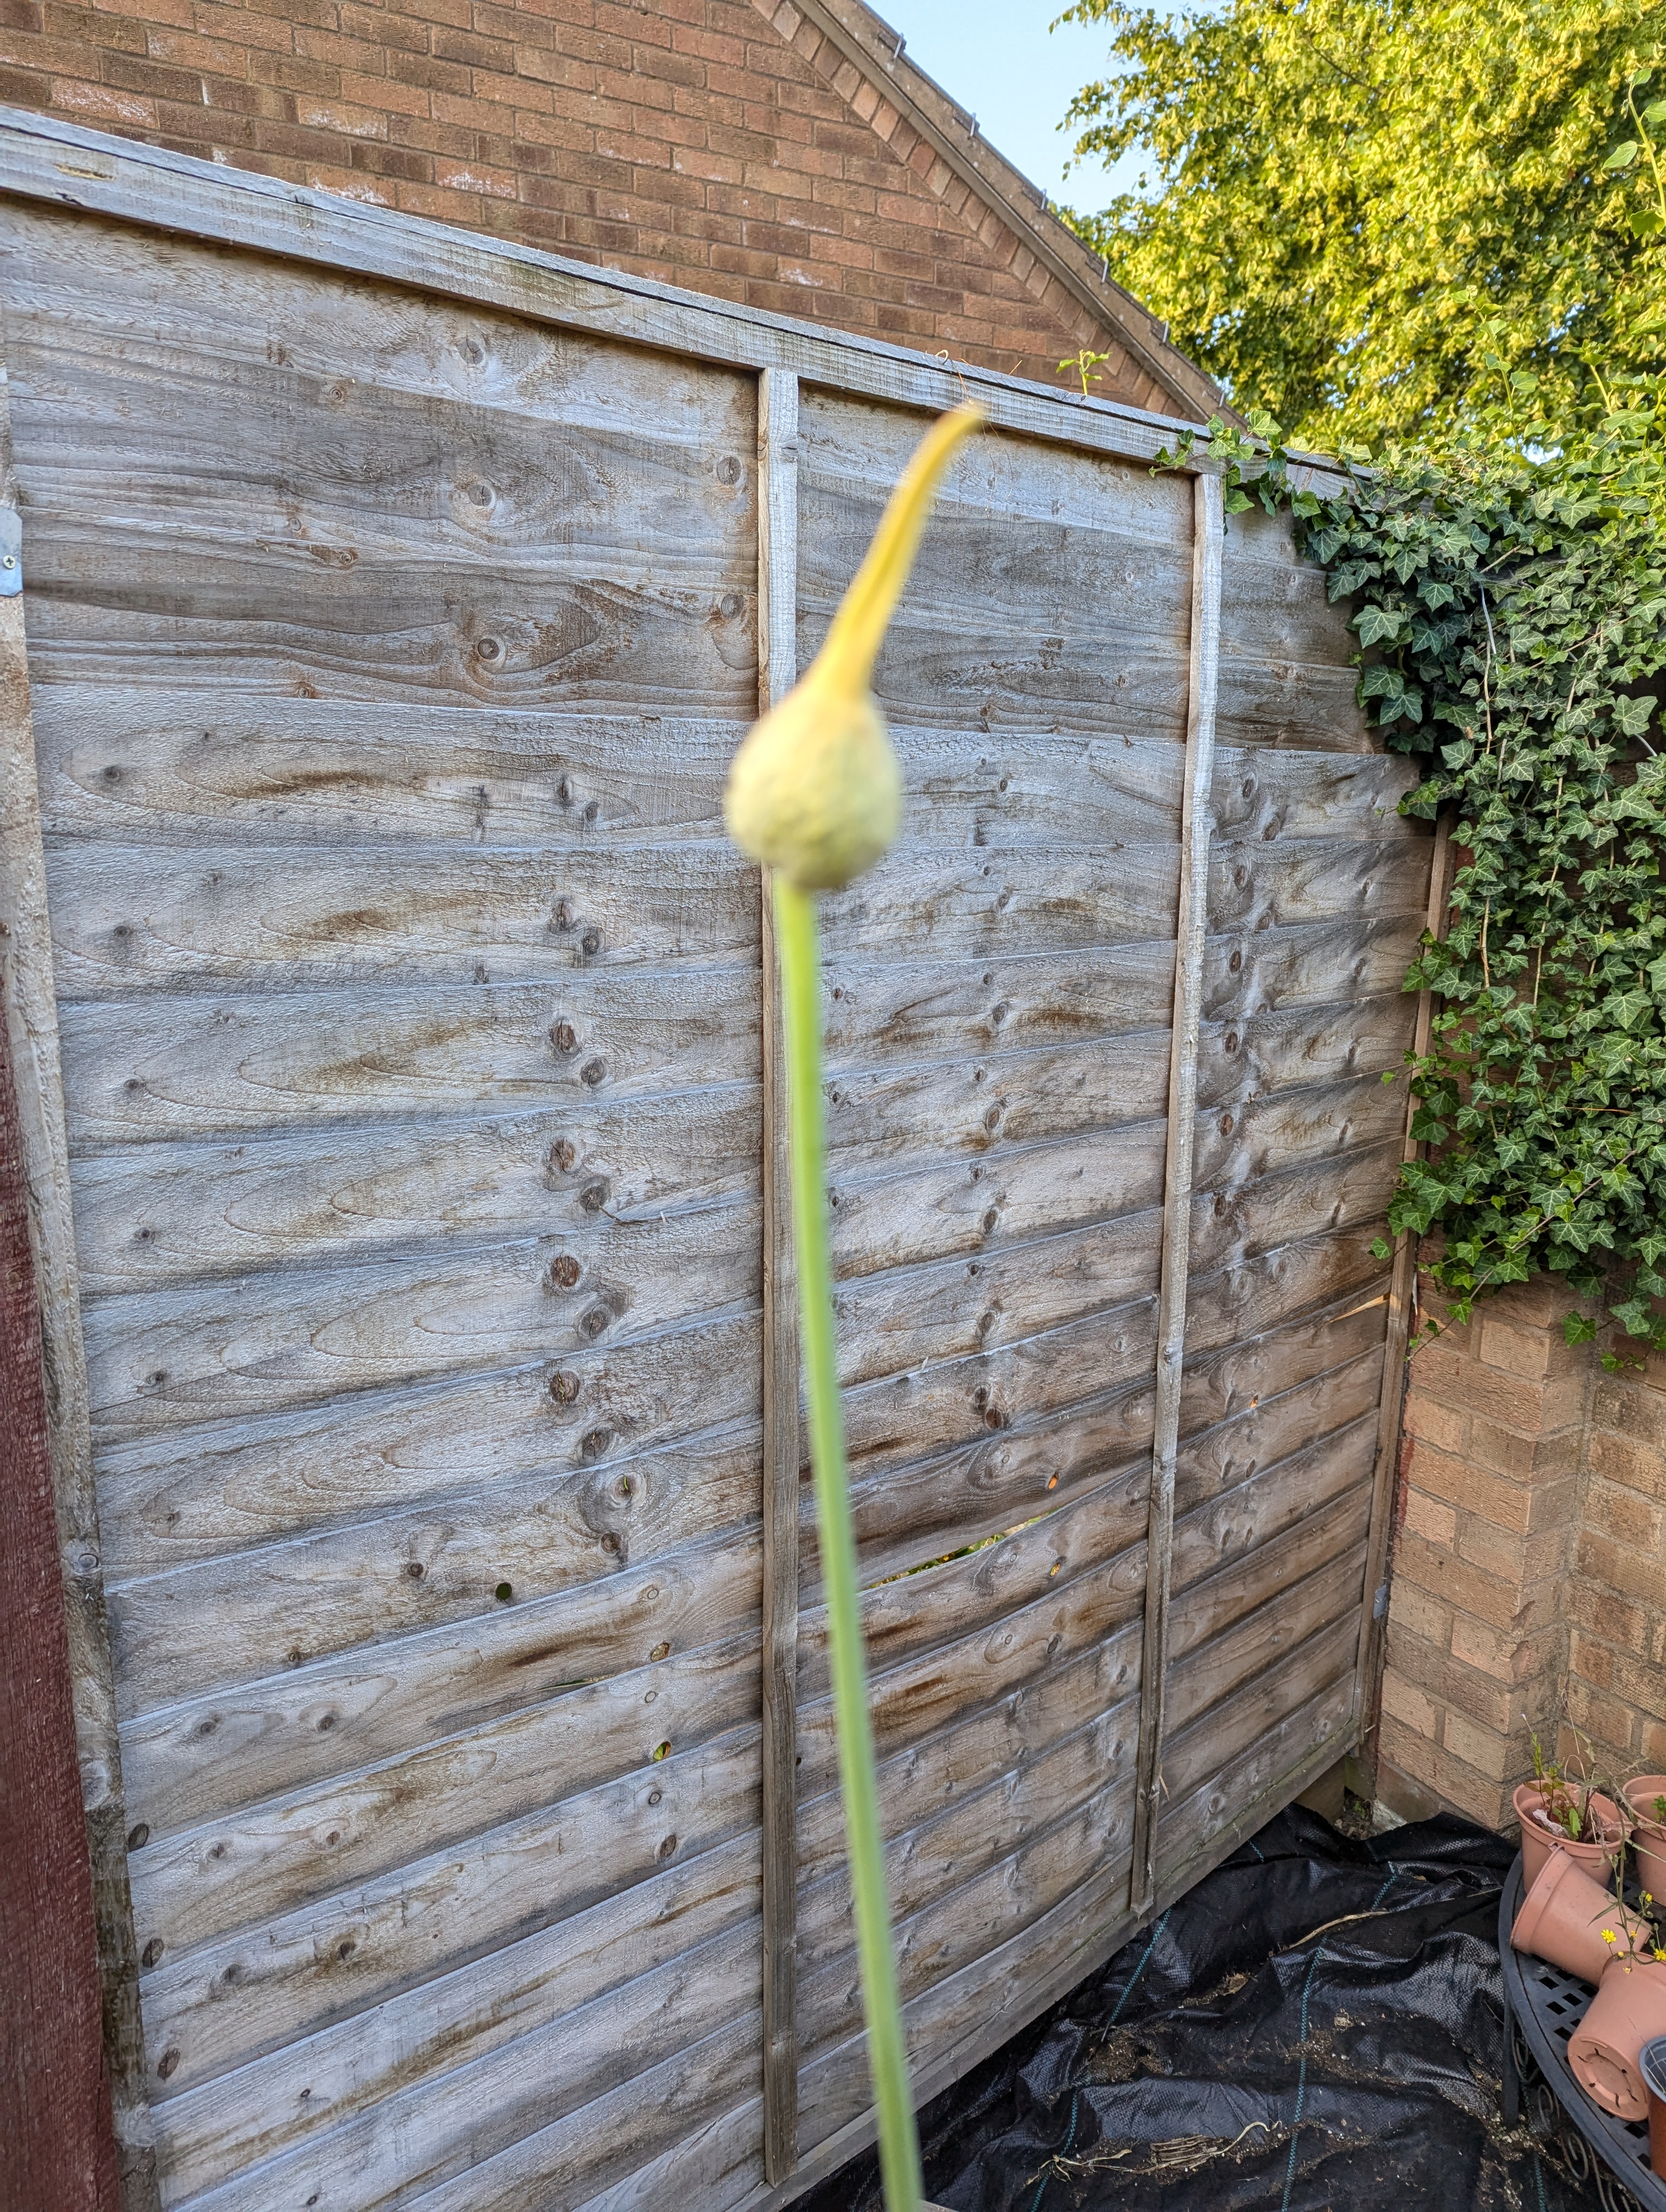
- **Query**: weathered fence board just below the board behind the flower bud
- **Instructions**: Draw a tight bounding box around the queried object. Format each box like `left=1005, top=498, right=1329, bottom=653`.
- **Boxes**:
left=49, top=840, right=1195, bottom=1000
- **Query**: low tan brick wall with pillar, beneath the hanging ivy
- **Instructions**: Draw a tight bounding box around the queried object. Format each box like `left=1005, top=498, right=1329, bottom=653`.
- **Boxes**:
left=1376, top=1281, right=1666, bottom=1827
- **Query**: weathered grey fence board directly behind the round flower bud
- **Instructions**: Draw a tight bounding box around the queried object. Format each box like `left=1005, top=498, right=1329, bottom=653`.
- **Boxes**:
left=37, top=684, right=1186, bottom=854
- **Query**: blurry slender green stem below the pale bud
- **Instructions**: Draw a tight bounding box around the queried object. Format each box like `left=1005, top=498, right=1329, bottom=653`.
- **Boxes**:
left=774, top=876, right=925, bottom=2212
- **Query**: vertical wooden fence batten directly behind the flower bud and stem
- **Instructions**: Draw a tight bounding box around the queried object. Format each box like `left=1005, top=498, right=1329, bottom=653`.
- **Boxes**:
left=759, top=369, right=801, bottom=2181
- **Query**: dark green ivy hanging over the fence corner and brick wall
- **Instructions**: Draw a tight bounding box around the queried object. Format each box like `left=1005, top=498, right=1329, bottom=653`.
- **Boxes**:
left=1164, top=384, right=1666, bottom=1349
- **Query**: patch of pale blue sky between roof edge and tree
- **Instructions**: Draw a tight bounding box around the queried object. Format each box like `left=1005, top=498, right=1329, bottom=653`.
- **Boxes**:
left=869, top=0, right=1139, bottom=213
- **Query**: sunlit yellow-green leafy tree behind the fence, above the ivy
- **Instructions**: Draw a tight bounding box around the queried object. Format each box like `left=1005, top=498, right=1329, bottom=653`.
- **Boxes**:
left=1062, top=0, right=1666, bottom=449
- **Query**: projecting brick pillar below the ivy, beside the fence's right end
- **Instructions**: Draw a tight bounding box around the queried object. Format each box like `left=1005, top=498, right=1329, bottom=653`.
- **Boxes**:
left=1376, top=1278, right=1593, bottom=1827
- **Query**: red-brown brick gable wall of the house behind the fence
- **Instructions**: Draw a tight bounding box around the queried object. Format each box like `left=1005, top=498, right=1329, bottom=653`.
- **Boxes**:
left=0, top=0, right=1175, bottom=411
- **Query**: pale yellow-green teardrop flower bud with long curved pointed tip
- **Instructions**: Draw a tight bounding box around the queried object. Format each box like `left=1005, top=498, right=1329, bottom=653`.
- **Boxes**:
left=723, top=407, right=982, bottom=891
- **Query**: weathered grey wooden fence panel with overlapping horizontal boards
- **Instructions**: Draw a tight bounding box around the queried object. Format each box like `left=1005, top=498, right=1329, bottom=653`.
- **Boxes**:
left=0, top=115, right=1429, bottom=2212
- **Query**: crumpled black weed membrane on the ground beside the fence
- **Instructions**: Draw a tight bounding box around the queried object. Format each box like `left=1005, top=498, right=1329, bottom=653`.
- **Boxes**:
left=801, top=1807, right=1591, bottom=2212
